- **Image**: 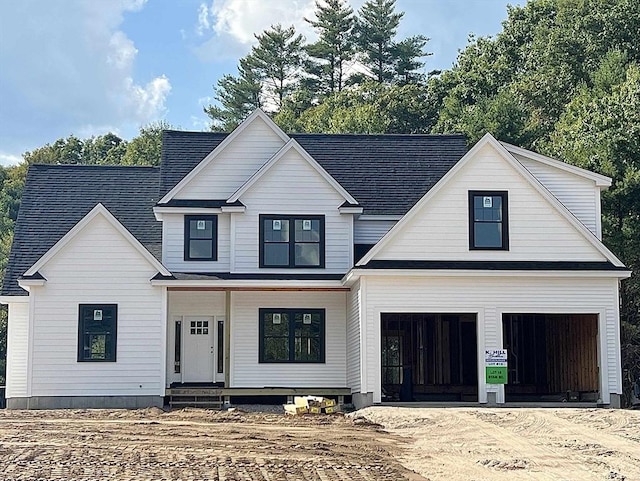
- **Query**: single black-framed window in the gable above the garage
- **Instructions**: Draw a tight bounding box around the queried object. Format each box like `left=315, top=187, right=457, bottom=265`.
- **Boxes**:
left=469, top=191, right=509, bottom=250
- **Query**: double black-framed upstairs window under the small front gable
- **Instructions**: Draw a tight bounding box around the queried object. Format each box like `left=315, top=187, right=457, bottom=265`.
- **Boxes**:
left=260, top=215, right=324, bottom=267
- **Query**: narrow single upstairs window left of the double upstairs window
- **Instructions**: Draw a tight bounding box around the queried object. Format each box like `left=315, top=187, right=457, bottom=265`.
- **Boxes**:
left=184, top=215, right=218, bottom=261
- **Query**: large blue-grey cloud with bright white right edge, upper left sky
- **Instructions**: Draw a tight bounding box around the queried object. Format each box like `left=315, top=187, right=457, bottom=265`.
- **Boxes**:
left=0, top=0, right=171, bottom=158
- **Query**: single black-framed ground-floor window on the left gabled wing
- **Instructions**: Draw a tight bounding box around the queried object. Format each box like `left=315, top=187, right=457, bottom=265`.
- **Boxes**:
left=78, top=304, right=118, bottom=362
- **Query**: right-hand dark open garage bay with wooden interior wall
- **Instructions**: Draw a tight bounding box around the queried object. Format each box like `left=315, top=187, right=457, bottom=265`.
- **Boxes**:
left=502, top=314, right=599, bottom=402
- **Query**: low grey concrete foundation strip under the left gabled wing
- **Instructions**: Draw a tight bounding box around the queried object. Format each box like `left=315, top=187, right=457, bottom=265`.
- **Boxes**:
left=7, top=396, right=164, bottom=409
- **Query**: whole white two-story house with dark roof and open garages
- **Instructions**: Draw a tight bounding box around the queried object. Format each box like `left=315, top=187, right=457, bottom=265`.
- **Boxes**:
left=0, top=110, right=630, bottom=408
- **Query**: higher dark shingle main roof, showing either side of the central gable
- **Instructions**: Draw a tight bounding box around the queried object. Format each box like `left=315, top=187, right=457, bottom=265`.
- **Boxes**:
left=160, top=131, right=467, bottom=215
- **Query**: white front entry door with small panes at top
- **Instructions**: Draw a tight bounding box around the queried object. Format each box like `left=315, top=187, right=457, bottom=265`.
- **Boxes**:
left=182, top=316, right=215, bottom=382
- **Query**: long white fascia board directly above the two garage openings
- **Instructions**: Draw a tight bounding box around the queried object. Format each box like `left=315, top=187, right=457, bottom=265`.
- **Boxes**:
left=342, top=269, right=631, bottom=285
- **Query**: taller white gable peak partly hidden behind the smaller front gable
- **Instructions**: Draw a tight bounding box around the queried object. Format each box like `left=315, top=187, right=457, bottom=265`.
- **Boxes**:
left=158, top=109, right=290, bottom=205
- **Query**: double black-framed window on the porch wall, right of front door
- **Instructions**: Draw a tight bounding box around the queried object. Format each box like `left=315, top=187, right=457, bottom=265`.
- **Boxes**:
left=259, top=309, right=325, bottom=363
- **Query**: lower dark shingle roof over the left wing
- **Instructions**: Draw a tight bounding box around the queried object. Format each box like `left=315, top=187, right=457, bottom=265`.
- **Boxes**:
left=2, top=165, right=162, bottom=295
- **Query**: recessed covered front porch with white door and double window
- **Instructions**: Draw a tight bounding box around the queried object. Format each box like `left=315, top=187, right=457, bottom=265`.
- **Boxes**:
left=156, top=280, right=351, bottom=406
